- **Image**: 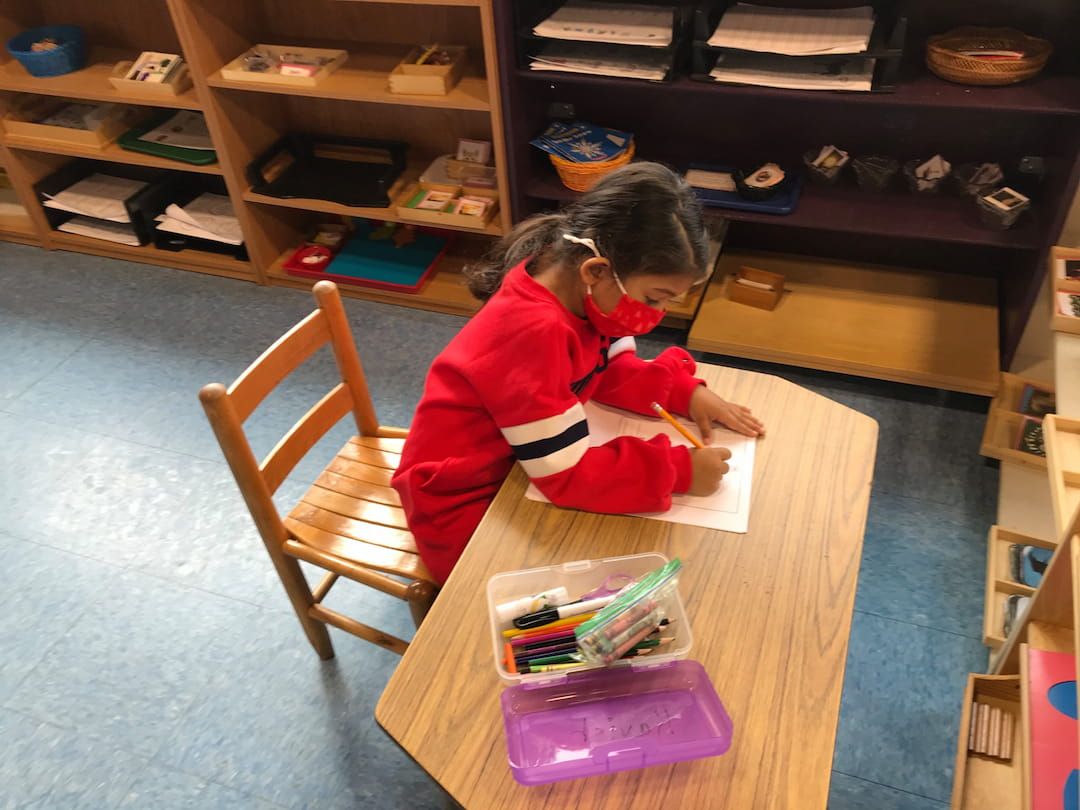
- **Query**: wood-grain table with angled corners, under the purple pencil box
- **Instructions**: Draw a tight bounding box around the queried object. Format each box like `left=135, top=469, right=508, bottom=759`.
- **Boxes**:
left=375, top=365, right=877, bottom=810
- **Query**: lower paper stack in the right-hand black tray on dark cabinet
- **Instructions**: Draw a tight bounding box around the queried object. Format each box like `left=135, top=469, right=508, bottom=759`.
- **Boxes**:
left=708, top=53, right=875, bottom=92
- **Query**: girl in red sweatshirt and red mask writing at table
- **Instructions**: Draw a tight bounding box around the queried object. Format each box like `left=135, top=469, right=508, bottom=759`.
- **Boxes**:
left=393, top=163, right=764, bottom=582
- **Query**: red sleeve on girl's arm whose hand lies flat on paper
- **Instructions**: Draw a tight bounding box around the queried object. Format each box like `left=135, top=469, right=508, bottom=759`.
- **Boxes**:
left=593, top=338, right=705, bottom=416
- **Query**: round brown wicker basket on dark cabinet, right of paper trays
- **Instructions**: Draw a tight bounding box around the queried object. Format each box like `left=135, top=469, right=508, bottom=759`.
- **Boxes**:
left=927, top=26, right=1054, bottom=85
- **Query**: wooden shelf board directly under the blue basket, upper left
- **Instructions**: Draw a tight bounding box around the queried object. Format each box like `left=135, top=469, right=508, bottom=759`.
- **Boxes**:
left=0, top=49, right=202, bottom=110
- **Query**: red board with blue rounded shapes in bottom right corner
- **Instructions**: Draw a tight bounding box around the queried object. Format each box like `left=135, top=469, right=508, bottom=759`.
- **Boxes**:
left=1027, top=648, right=1078, bottom=810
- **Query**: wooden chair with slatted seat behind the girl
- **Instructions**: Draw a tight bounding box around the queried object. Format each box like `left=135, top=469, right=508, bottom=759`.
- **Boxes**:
left=199, top=281, right=437, bottom=659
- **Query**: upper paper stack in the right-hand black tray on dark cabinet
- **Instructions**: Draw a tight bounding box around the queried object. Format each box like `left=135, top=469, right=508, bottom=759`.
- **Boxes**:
left=708, top=3, right=874, bottom=56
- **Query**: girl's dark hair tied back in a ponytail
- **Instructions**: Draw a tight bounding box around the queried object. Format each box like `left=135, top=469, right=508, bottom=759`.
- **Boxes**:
left=464, top=162, right=708, bottom=301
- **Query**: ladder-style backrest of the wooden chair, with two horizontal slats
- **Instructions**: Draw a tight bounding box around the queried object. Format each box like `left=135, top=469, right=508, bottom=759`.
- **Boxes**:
left=199, top=281, right=407, bottom=543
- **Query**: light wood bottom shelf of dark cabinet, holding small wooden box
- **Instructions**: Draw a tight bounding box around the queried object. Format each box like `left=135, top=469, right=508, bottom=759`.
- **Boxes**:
left=687, top=251, right=1000, bottom=395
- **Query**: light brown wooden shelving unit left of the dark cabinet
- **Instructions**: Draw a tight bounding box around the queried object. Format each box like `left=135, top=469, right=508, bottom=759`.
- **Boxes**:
left=0, top=0, right=511, bottom=314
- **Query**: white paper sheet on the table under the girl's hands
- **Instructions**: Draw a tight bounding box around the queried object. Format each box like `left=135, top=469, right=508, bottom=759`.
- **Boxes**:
left=525, top=402, right=757, bottom=534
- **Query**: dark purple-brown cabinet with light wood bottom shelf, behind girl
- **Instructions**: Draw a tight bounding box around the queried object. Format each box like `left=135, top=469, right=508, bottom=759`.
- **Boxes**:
left=496, top=0, right=1080, bottom=394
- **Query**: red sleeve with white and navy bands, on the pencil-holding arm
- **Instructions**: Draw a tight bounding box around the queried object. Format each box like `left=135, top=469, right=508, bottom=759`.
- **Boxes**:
left=471, top=326, right=692, bottom=514
